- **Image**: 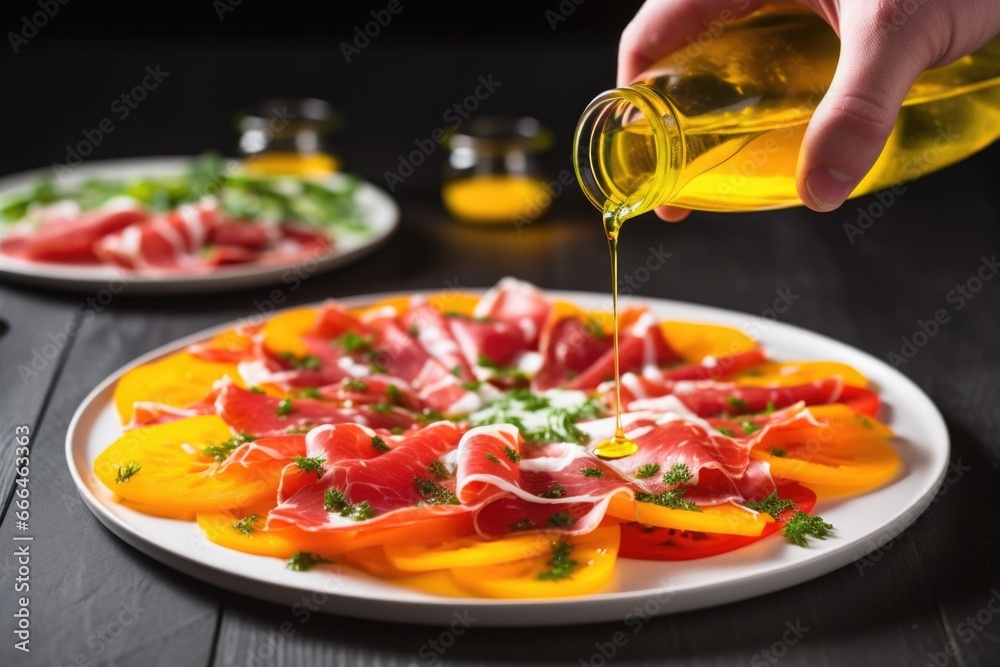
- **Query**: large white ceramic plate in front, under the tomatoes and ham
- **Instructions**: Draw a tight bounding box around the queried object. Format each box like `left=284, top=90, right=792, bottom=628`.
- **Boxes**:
left=66, top=292, right=949, bottom=626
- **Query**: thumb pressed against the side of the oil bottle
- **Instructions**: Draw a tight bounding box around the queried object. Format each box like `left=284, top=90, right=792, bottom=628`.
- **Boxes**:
left=796, top=17, right=929, bottom=211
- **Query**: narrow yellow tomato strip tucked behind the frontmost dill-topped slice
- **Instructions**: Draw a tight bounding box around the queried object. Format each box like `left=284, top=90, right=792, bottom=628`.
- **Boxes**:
left=385, top=533, right=551, bottom=572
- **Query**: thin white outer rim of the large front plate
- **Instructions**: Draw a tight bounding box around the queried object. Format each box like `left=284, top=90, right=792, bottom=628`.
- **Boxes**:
left=65, top=288, right=951, bottom=627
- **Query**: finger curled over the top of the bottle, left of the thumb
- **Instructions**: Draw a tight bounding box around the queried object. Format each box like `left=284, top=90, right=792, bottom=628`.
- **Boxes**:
left=618, top=0, right=763, bottom=86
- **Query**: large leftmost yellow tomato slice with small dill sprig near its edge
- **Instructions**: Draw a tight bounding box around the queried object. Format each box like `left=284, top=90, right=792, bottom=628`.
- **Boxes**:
left=94, top=415, right=281, bottom=512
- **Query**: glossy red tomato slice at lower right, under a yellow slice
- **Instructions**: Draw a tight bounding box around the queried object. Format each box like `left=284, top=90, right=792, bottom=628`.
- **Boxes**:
left=619, top=483, right=816, bottom=560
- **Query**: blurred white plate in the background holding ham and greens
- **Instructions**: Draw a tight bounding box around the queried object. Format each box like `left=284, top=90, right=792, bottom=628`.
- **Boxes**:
left=0, top=157, right=399, bottom=294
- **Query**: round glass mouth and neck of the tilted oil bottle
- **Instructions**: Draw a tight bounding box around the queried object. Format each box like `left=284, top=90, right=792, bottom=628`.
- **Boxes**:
left=573, top=84, right=685, bottom=219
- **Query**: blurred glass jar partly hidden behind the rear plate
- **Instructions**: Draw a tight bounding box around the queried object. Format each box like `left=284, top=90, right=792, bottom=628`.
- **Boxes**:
left=236, top=98, right=340, bottom=177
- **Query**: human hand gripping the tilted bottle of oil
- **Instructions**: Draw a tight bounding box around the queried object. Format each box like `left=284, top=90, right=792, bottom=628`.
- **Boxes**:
left=618, top=0, right=1000, bottom=222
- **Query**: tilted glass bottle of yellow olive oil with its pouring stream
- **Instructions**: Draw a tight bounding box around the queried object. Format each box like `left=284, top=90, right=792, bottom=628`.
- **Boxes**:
left=574, top=8, right=1000, bottom=454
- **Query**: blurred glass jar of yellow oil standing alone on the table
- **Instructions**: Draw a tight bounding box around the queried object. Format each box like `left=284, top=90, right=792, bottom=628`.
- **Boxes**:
left=441, top=116, right=552, bottom=230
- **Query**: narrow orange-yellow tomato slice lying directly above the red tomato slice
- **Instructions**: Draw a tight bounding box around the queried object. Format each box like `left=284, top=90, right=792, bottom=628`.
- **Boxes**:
left=608, top=494, right=774, bottom=537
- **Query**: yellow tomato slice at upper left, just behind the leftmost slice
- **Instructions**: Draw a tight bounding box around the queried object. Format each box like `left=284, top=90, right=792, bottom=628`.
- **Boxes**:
left=114, top=352, right=243, bottom=424
